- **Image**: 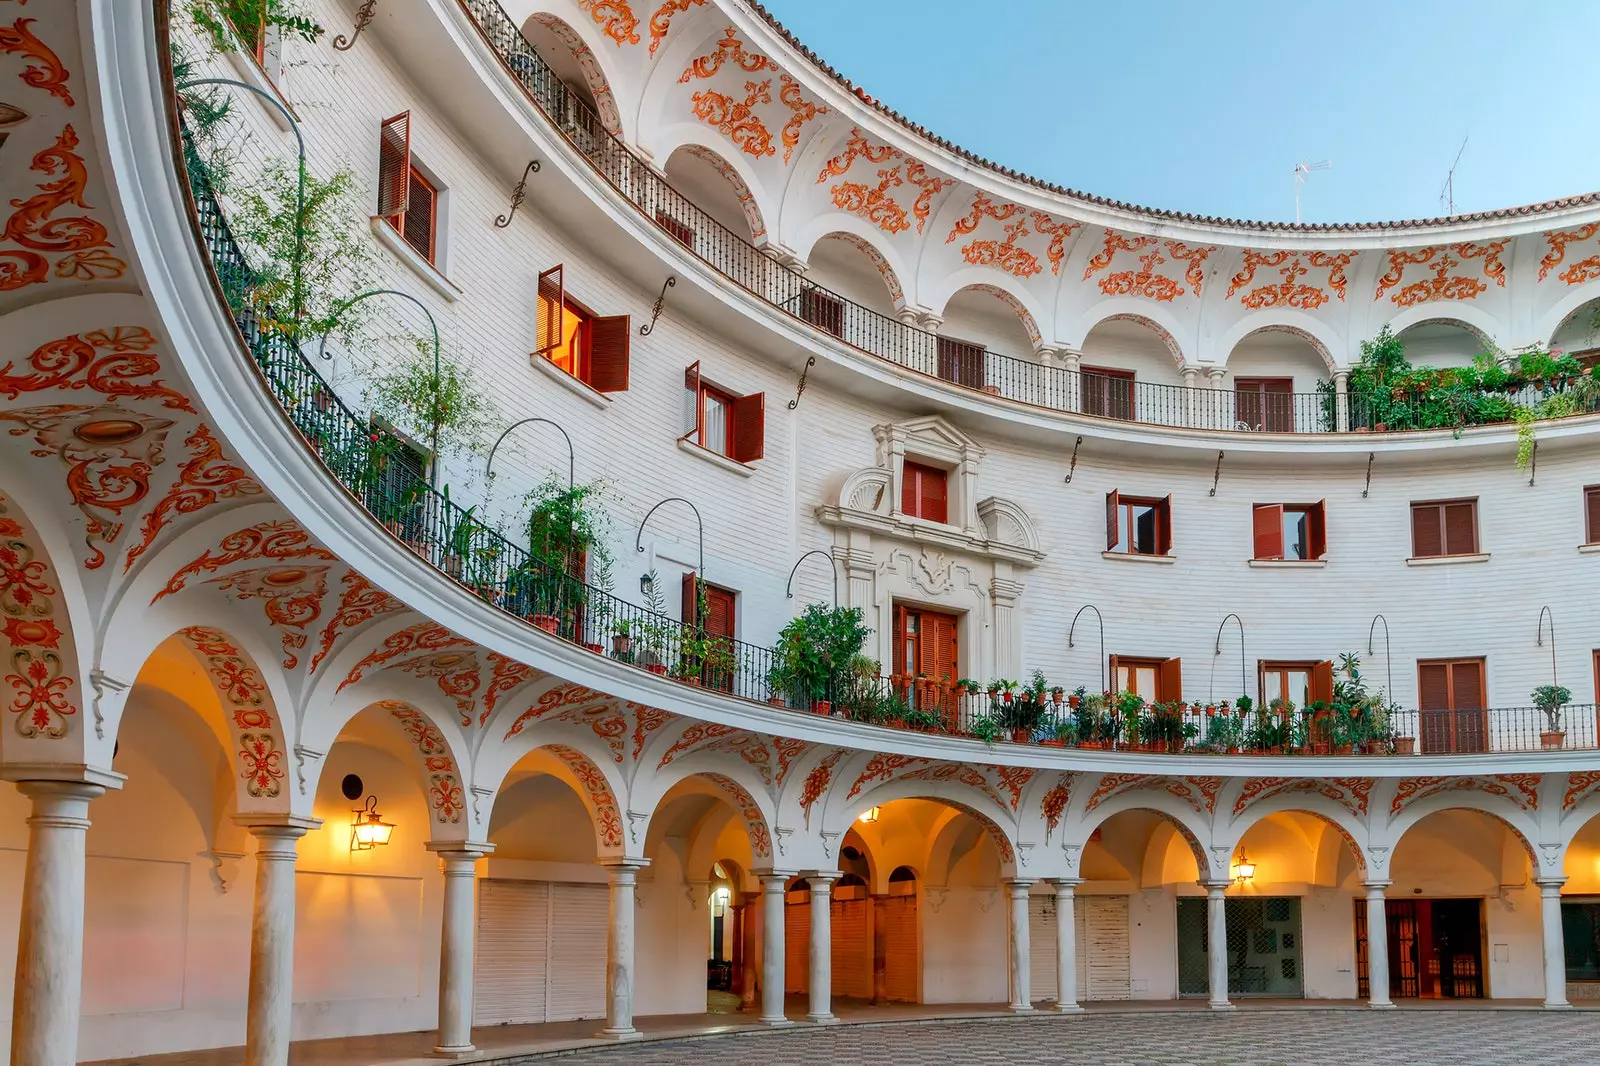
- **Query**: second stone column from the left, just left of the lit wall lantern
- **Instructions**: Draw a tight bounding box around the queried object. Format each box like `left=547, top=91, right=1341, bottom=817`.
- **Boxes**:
left=234, top=815, right=322, bottom=1066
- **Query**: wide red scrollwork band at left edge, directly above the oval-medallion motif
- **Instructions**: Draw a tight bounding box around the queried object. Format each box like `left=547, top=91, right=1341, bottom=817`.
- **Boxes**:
left=0, top=328, right=195, bottom=415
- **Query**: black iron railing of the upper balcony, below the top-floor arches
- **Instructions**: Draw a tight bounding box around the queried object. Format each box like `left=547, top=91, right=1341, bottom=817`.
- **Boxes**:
left=458, top=0, right=1600, bottom=434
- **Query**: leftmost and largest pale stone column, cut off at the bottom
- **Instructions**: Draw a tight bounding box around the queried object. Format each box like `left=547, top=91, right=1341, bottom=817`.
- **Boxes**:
left=11, top=781, right=106, bottom=1066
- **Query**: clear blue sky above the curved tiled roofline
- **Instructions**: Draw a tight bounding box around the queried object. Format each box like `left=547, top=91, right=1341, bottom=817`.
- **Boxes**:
left=765, top=0, right=1600, bottom=222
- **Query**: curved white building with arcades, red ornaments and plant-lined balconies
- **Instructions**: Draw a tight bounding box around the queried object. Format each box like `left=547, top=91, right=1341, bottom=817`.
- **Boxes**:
left=0, top=0, right=1600, bottom=1064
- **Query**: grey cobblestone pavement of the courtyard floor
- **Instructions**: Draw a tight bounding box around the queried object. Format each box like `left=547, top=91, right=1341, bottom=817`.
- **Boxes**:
left=553, top=1010, right=1600, bottom=1066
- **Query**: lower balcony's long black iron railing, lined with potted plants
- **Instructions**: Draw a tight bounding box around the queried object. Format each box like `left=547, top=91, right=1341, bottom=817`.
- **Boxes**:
left=172, top=49, right=1597, bottom=754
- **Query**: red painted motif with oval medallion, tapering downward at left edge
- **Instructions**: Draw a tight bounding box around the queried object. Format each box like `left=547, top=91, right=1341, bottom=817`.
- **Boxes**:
left=0, top=403, right=173, bottom=570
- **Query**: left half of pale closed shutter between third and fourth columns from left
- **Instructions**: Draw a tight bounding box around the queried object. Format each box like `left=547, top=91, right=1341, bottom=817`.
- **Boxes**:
left=472, top=879, right=550, bottom=1026
